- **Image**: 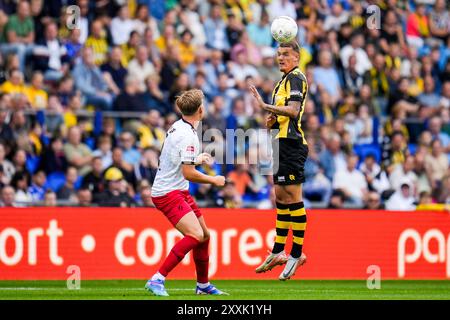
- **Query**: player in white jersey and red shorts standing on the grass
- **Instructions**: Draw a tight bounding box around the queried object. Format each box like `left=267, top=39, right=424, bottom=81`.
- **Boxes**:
left=145, top=90, right=225, bottom=296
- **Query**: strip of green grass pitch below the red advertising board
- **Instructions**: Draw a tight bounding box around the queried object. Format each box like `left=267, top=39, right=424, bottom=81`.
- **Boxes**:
left=0, top=280, right=450, bottom=300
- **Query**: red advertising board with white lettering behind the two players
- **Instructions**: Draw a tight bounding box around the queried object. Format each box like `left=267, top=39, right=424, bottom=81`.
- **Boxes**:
left=0, top=208, right=450, bottom=280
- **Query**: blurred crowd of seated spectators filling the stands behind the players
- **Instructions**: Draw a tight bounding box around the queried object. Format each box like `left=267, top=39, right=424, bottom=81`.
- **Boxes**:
left=0, top=0, right=450, bottom=210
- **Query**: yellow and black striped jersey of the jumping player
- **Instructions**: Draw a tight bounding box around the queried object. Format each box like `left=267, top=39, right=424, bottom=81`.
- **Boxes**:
left=271, top=67, right=308, bottom=144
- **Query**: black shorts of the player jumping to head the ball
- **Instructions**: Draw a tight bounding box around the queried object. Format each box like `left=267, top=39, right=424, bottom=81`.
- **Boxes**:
left=272, top=139, right=308, bottom=185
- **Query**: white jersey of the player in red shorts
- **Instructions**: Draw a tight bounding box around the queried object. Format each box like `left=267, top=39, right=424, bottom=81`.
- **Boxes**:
left=152, top=119, right=200, bottom=197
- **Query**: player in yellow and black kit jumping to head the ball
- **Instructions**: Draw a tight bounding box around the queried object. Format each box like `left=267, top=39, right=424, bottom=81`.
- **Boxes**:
left=250, top=41, right=308, bottom=280
